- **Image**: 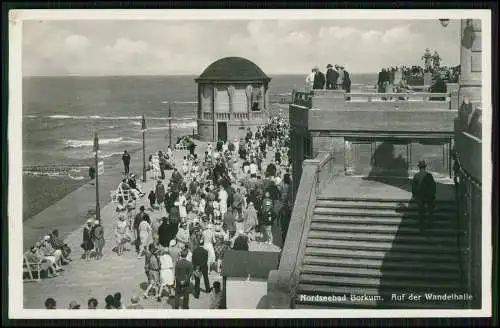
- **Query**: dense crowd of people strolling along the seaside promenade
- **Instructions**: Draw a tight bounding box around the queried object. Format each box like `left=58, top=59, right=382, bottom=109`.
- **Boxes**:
left=38, top=117, right=292, bottom=309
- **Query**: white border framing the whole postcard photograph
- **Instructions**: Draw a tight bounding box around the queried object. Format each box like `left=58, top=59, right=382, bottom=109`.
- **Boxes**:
left=8, top=9, right=492, bottom=319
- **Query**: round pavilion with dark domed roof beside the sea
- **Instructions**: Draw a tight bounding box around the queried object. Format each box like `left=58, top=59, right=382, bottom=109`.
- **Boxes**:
left=195, top=57, right=271, bottom=142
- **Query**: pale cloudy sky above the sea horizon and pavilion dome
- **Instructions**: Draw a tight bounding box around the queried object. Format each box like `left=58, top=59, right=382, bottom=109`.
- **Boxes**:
left=22, top=19, right=460, bottom=76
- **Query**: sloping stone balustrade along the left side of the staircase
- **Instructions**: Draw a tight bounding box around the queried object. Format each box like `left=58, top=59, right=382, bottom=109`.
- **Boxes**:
left=268, top=152, right=334, bottom=309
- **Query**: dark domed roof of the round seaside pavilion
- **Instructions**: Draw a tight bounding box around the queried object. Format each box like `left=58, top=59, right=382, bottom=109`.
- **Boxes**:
left=195, top=57, right=271, bottom=82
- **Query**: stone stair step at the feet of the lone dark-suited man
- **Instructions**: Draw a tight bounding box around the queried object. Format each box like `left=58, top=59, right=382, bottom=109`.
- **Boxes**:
left=310, top=218, right=457, bottom=238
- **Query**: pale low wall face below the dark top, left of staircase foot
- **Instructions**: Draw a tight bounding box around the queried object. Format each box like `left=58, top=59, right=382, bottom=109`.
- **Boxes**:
left=226, top=278, right=267, bottom=309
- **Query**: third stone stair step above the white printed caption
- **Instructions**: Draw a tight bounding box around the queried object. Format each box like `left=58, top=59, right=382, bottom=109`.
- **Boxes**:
left=303, top=255, right=458, bottom=273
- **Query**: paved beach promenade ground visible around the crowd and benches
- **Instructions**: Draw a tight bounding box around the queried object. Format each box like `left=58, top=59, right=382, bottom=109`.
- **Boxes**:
left=23, top=141, right=281, bottom=309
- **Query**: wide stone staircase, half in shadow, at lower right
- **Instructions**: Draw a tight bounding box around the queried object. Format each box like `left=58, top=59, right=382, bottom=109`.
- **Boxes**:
left=295, top=195, right=465, bottom=309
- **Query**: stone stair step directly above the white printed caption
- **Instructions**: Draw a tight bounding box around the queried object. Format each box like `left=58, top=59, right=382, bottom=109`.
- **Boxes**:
left=299, top=273, right=460, bottom=293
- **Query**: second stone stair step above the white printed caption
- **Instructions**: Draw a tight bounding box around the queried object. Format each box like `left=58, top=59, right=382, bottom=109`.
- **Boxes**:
left=301, top=264, right=460, bottom=284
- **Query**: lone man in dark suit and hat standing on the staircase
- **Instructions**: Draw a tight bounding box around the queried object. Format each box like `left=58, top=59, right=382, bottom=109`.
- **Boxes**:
left=412, top=161, right=436, bottom=231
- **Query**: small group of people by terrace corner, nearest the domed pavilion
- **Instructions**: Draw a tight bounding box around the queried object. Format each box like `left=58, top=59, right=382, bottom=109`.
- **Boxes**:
left=306, top=64, right=351, bottom=93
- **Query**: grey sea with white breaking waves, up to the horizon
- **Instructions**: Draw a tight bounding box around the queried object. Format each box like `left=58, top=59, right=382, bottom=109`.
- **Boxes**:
left=22, top=74, right=377, bottom=179
